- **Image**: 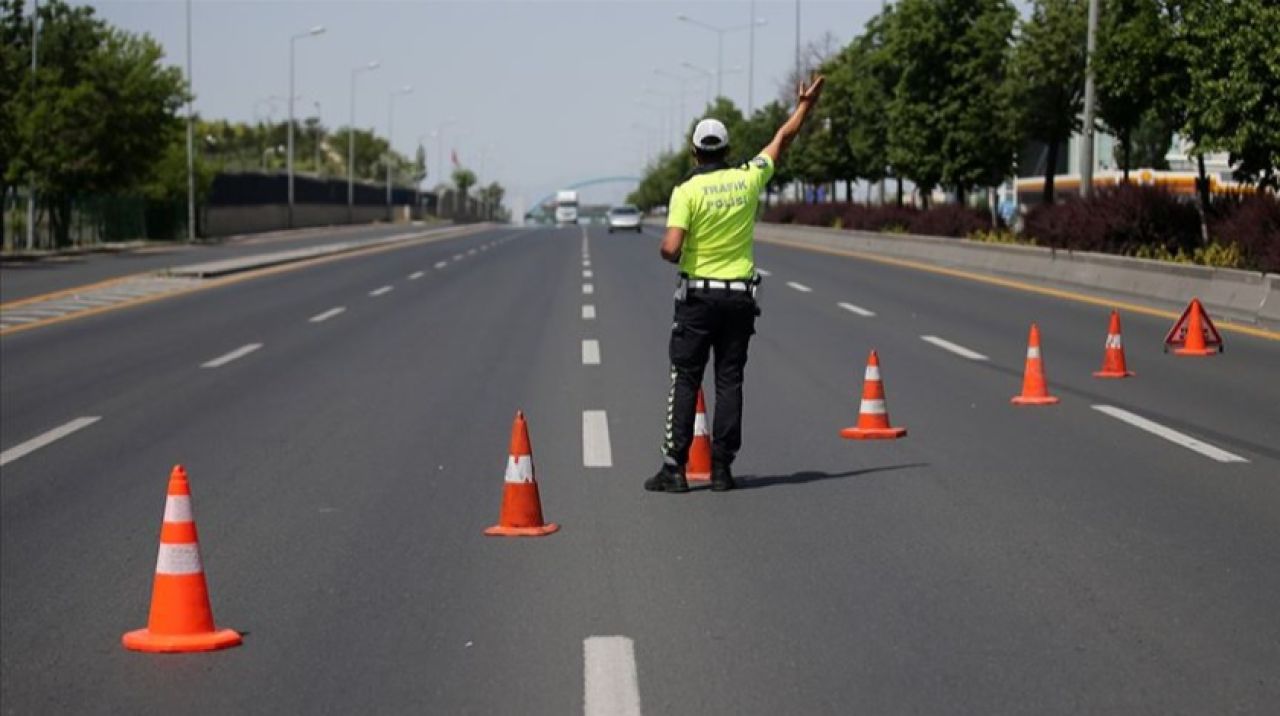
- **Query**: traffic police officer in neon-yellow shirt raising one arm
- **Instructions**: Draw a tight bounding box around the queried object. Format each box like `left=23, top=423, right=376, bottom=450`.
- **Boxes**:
left=644, top=76, right=823, bottom=492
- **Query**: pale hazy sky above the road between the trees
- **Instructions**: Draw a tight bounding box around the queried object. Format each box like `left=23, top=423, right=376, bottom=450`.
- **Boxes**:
left=87, top=0, right=881, bottom=206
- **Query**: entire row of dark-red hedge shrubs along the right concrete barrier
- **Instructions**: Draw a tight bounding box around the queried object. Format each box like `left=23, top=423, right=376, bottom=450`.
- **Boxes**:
left=764, top=186, right=1280, bottom=273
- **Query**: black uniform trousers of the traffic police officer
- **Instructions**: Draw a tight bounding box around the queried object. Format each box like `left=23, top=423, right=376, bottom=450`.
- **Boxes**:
left=663, top=288, right=759, bottom=466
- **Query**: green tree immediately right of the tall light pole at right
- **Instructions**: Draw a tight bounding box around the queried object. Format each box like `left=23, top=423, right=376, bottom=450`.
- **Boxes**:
left=1093, top=0, right=1181, bottom=182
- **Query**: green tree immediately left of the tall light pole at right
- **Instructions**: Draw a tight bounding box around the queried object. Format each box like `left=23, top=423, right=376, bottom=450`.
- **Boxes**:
left=1009, top=0, right=1088, bottom=204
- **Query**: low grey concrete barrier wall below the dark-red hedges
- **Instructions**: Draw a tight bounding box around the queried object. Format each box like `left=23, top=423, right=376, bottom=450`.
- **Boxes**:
left=755, top=223, right=1280, bottom=325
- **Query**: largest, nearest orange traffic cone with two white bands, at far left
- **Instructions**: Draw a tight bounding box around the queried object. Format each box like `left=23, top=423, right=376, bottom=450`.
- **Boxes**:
left=122, top=465, right=241, bottom=652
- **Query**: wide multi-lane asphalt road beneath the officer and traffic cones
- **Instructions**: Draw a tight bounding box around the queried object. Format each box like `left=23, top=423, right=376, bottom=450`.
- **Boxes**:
left=0, top=222, right=1280, bottom=715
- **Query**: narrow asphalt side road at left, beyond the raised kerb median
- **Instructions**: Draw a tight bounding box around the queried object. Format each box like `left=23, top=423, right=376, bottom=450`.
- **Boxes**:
left=0, top=224, right=430, bottom=304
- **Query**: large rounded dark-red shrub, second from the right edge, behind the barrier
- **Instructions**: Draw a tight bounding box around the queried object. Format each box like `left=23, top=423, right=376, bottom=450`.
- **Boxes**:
left=1023, top=186, right=1201, bottom=255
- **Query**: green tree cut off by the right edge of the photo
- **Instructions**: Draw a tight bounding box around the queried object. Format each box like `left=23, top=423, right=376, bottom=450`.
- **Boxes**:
left=1179, top=0, right=1280, bottom=189
